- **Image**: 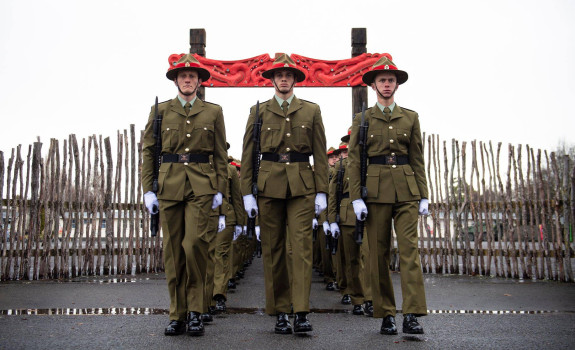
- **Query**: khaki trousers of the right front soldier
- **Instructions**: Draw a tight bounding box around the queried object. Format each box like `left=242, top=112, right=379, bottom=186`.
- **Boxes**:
left=367, top=201, right=427, bottom=318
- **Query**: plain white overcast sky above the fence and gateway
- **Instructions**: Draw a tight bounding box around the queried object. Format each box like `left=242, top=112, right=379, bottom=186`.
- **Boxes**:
left=0, top=0, right=575, bottom=157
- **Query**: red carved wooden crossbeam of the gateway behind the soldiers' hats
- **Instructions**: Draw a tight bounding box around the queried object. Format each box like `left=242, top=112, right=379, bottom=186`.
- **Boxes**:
left=195, top=53, right=388, bottom=87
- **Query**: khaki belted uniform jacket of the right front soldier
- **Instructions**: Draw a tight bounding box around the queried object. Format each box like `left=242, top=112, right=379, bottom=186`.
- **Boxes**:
left=348, top=104, right=428, bottom=203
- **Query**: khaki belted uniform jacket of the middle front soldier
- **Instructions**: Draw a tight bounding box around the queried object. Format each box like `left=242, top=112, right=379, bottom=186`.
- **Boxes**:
left=241, top=96, right=328, bottom=199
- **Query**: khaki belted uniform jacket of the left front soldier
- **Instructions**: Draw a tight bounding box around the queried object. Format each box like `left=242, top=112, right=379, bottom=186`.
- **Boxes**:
left=142, top=98, right=228, bottom=201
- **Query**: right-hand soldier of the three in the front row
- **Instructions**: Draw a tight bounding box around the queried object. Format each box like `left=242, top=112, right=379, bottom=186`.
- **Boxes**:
left=348, top=54, right=428, bottom=334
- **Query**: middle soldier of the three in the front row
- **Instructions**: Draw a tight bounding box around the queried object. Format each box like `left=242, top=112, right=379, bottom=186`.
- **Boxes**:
left=241, top=54, right=328, bottom=334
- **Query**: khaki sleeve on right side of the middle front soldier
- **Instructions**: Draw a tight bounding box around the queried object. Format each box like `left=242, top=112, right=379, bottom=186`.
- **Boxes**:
left=312, top=105, right=329, bottom=193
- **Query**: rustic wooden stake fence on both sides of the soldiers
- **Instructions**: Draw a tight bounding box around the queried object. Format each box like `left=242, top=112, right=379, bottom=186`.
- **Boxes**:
left=0, top=125, right=575, bottom=282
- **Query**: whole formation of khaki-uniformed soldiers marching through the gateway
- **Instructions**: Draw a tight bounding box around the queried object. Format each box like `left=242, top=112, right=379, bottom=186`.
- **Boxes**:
left=142, top=54, right=428, bottom=336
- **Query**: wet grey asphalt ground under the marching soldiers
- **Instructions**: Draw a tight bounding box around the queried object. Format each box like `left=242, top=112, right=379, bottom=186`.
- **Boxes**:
left=0, top=254, right=575, bottom=350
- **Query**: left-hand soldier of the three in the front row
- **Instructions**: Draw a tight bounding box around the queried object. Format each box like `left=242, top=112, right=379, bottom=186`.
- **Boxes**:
left=142, top=54, right=228, bottom=335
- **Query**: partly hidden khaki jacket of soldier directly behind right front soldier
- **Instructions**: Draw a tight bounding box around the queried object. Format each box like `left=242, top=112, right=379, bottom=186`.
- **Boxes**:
left=326, top=158, right=356, bottom=226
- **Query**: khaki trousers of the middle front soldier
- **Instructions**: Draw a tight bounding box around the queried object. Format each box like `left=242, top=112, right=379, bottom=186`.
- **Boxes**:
left=258, top=194, right=315, bottom=315
